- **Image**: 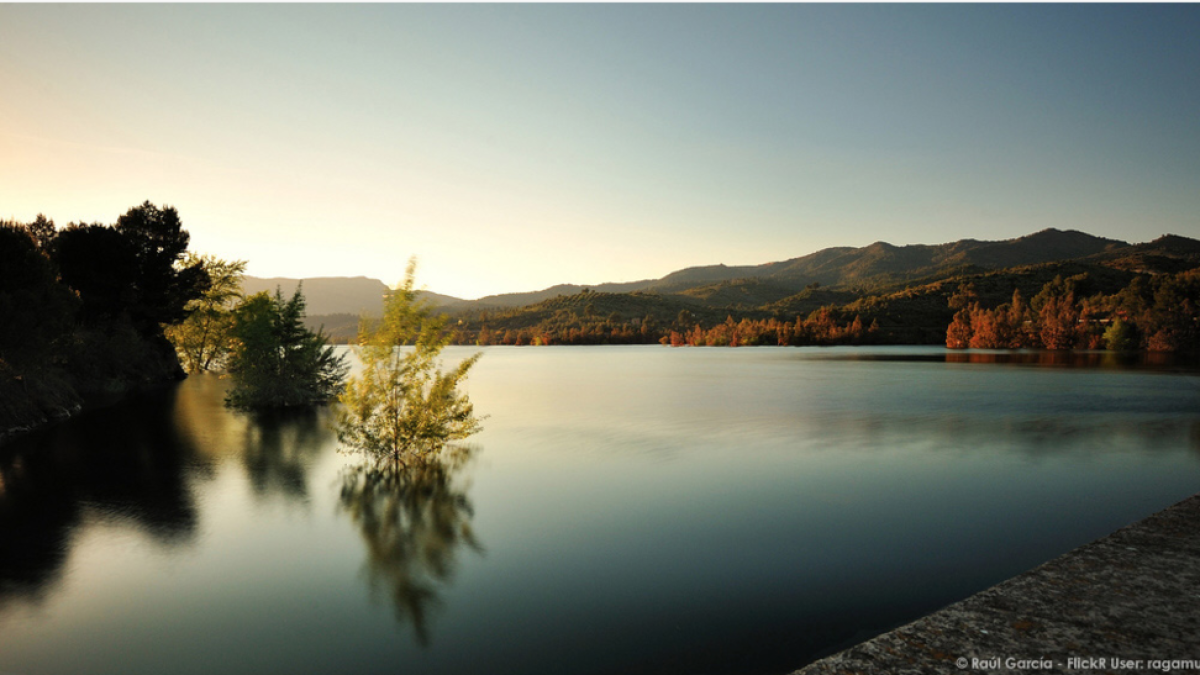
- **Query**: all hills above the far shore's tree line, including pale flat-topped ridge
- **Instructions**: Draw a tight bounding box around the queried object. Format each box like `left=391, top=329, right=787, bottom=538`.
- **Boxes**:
left=244, top=229, right=1200, bottom=340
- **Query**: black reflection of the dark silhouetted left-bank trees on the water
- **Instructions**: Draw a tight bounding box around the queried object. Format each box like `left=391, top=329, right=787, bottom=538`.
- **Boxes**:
left=0, top=389, right=202, bottom=605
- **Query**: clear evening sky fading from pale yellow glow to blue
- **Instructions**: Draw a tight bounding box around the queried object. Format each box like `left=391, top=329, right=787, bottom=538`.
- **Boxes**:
left=0, top=4, right=1200, bottom=298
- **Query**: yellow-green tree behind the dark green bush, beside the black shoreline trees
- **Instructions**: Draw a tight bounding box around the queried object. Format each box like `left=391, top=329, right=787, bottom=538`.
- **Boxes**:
left=167, top=253, right=246, bottom=372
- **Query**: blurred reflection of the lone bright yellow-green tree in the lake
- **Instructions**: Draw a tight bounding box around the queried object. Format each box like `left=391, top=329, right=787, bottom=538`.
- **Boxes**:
left=341, top=446, right=482, bottom=646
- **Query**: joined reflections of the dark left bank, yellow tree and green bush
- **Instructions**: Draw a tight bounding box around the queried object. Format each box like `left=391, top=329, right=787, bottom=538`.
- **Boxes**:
left=0, top=375, right=334, bottom=607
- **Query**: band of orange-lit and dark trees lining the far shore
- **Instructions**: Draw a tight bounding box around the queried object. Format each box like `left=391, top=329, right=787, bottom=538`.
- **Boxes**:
left=408, top=263, right=1200, bottom=353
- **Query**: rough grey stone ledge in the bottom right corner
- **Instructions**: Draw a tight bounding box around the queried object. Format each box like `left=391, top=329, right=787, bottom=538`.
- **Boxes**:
left=793, top=495, right=1200, bottom=675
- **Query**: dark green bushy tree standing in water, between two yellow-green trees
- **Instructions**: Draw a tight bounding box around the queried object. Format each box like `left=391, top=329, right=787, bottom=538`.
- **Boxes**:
left=226, top=287, right=349, bottom=408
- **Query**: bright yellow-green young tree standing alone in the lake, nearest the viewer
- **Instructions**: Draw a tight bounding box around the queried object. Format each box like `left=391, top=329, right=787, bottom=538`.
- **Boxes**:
left=337, top=262, right=481, bottom=465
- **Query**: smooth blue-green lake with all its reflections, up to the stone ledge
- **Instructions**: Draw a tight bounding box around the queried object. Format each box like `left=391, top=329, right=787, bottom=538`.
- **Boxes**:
left=0, top=346, right=1200, bottom=675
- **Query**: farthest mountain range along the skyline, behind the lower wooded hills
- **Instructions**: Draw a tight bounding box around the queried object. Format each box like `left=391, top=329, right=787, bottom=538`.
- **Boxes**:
left=242, top=228, right=1200, bottom=335
